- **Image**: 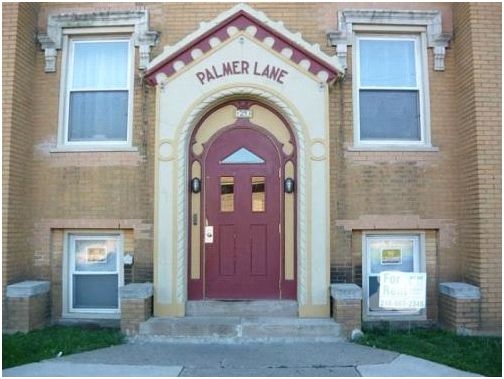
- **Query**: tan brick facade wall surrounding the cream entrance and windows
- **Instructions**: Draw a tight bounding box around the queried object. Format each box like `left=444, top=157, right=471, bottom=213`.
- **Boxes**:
left=3, top=2, right=501, bottom=332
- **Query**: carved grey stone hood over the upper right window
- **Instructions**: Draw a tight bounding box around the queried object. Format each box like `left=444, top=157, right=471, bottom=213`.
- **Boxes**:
left=327, top=10, right=452, bottom=71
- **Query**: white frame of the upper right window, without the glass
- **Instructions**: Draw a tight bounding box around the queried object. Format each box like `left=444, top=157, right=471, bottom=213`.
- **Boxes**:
left=352, top=27, right=432, bottom=150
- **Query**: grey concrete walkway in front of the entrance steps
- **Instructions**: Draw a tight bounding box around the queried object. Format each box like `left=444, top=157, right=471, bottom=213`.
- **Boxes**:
left=2, top=342, right=478, bottom=377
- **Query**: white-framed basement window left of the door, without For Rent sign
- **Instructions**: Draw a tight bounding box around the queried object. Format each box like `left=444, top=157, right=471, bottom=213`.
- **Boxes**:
left=63, top=231, right=124, bottom=319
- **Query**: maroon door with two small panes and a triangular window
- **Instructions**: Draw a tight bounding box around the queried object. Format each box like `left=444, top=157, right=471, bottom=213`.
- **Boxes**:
left=204, top=126, right=282, bottom=299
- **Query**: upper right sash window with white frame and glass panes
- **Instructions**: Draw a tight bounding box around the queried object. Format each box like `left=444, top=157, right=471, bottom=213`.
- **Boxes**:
left=354, top=34, right=430, bottom=146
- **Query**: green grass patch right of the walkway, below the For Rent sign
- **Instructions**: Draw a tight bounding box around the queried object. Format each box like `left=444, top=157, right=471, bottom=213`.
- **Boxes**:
left=359, top=329, right=502, bottom=377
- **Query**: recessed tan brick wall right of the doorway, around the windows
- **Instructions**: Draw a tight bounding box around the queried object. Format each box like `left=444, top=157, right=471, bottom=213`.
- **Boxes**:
left=330, top=8, right=460, bottom=294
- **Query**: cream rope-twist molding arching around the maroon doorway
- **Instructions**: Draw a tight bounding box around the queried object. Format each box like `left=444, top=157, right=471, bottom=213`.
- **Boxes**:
left=176, top=87, right=308, bottom=304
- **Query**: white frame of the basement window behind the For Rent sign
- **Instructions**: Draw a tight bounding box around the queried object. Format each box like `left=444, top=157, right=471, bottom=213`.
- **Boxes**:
left=362, top=231, right=427, bottom=321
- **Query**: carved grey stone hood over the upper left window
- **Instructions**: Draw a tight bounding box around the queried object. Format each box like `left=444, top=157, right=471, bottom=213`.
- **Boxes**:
left=37, top=10, right=159, bottom=72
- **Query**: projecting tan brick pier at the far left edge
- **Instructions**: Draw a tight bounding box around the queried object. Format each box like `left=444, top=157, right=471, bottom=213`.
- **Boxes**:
left=2, top=3, right=39, bottom=321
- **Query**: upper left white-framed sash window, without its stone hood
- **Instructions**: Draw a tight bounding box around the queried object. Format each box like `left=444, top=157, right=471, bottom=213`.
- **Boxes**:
left=58, top=27, right=135, bottom=150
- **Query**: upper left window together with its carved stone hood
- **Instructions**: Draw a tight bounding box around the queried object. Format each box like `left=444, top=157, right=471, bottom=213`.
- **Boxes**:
left=38, top=10, right=159, bottom=151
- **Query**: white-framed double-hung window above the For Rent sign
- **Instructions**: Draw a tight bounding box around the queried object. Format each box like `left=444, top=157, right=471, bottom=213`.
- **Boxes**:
left=353, top=26, right=432, bottom=149
